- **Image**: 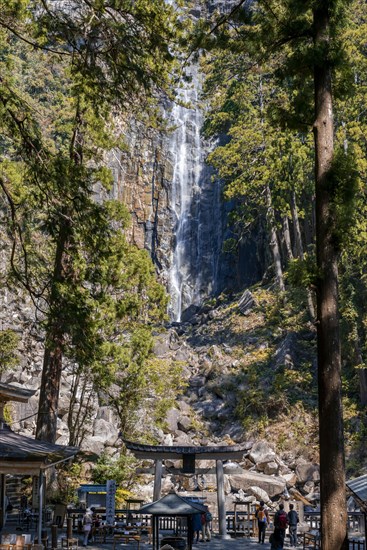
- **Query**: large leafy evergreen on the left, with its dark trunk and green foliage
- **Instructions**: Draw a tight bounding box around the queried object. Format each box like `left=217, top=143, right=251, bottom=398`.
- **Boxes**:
left=0, top=0, right=178, bottom=441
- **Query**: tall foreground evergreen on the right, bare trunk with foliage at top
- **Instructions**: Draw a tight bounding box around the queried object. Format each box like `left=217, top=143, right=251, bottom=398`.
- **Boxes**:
left=203, top=0, right=355, bottom=550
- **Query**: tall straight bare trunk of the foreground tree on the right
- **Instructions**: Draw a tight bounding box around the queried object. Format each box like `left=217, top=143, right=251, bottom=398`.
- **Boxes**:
left=313, top=2, right=347, bottom=550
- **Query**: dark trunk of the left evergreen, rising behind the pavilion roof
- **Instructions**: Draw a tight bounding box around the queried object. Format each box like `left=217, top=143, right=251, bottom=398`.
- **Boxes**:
left=36, top=226, right=69, bottom=443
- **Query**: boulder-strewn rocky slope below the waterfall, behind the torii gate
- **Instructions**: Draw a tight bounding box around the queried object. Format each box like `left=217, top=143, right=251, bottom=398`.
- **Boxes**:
left=3, top=289, right=319, bottom=509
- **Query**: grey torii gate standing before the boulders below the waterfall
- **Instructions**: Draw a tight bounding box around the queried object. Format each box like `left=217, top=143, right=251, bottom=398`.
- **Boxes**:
left=123, top=439, right=249, bottom=538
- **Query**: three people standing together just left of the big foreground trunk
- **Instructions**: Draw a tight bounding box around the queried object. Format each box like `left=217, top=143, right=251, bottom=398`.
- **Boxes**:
left=255, top=500, right=299, bottom=550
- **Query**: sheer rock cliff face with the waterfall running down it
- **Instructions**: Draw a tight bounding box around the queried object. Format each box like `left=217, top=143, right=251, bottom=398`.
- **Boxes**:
left=108, top=2, right=259, bottom=321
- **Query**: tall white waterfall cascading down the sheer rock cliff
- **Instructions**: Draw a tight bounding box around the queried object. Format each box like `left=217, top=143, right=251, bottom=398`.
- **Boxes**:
left=168, top=65, right=222, bottom=321
